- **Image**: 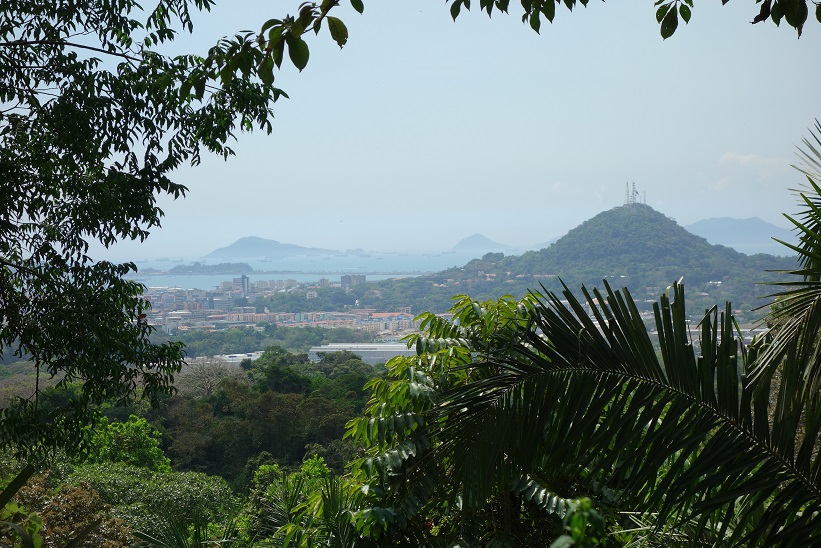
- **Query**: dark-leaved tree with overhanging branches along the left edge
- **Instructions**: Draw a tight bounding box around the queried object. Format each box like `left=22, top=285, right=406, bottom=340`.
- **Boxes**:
left=0, top=0, right=362, bottom=458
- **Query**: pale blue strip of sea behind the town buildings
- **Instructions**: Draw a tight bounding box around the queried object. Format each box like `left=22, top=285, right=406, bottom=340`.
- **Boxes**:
left=123, top=252, right=494, bottom=289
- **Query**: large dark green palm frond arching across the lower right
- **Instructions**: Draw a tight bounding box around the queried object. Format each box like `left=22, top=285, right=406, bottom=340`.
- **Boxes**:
left=435, top=283, right=821, bottom=544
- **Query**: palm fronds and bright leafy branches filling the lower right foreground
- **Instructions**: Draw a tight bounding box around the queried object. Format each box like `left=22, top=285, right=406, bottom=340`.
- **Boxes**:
left=286, top=125, right=821, bottom=546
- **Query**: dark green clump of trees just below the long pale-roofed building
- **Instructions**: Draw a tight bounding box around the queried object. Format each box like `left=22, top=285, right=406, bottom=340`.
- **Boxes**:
left=146, top=347, right=374, bottom=484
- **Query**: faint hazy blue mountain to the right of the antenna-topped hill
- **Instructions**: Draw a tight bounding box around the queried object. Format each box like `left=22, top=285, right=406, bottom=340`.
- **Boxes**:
left=684, top=217, right=796, bottom=256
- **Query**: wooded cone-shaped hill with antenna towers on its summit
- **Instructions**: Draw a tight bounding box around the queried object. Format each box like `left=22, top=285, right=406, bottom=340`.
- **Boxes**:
left=359, top=204, right=794, bottom=319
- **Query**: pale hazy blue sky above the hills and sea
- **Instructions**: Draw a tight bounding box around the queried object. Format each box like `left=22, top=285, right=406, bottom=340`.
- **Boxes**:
left=88, top=0, right=821, bottom=260
